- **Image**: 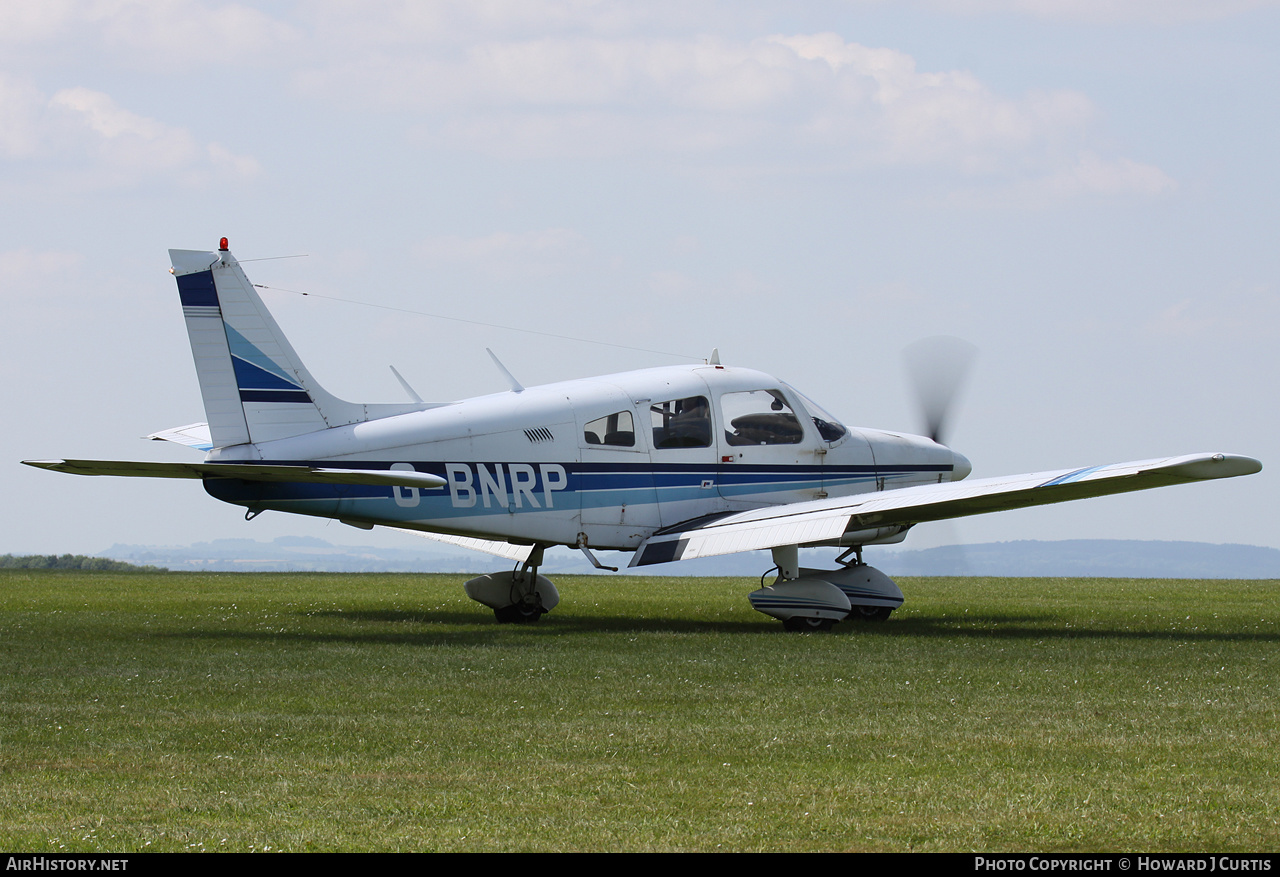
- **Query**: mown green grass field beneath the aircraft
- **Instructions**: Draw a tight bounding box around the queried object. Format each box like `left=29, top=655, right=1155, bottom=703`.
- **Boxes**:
left=0, top=572, right=1280, bottom=851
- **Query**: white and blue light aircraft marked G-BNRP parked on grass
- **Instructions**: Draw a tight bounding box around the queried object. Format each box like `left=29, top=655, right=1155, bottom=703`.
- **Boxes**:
left=24, top=238, right=1262, bottom=630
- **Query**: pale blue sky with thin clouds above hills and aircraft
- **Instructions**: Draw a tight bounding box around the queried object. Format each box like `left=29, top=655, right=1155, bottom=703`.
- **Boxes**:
left=0, top=0, right=1280, bottom=553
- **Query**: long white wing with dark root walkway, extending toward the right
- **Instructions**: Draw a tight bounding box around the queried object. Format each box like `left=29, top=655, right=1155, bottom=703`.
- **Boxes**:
left=631, top=453, right=1262, bottom=566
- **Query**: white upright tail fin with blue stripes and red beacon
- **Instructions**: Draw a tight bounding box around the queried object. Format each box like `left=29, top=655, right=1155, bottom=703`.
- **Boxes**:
left=169, top=238, right=430, bottom=448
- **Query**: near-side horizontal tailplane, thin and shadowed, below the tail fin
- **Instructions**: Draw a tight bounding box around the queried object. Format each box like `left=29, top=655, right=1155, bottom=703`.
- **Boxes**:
left=22, top=460, right=449, bottom=489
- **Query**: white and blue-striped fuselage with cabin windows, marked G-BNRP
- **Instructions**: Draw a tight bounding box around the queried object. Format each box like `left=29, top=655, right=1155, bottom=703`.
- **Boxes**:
left=206, top=365, right=969, bottom=549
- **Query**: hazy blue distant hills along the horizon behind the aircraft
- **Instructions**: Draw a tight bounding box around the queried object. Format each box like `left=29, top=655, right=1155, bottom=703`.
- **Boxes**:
left=92, top=536, right=1280, bottom=579
